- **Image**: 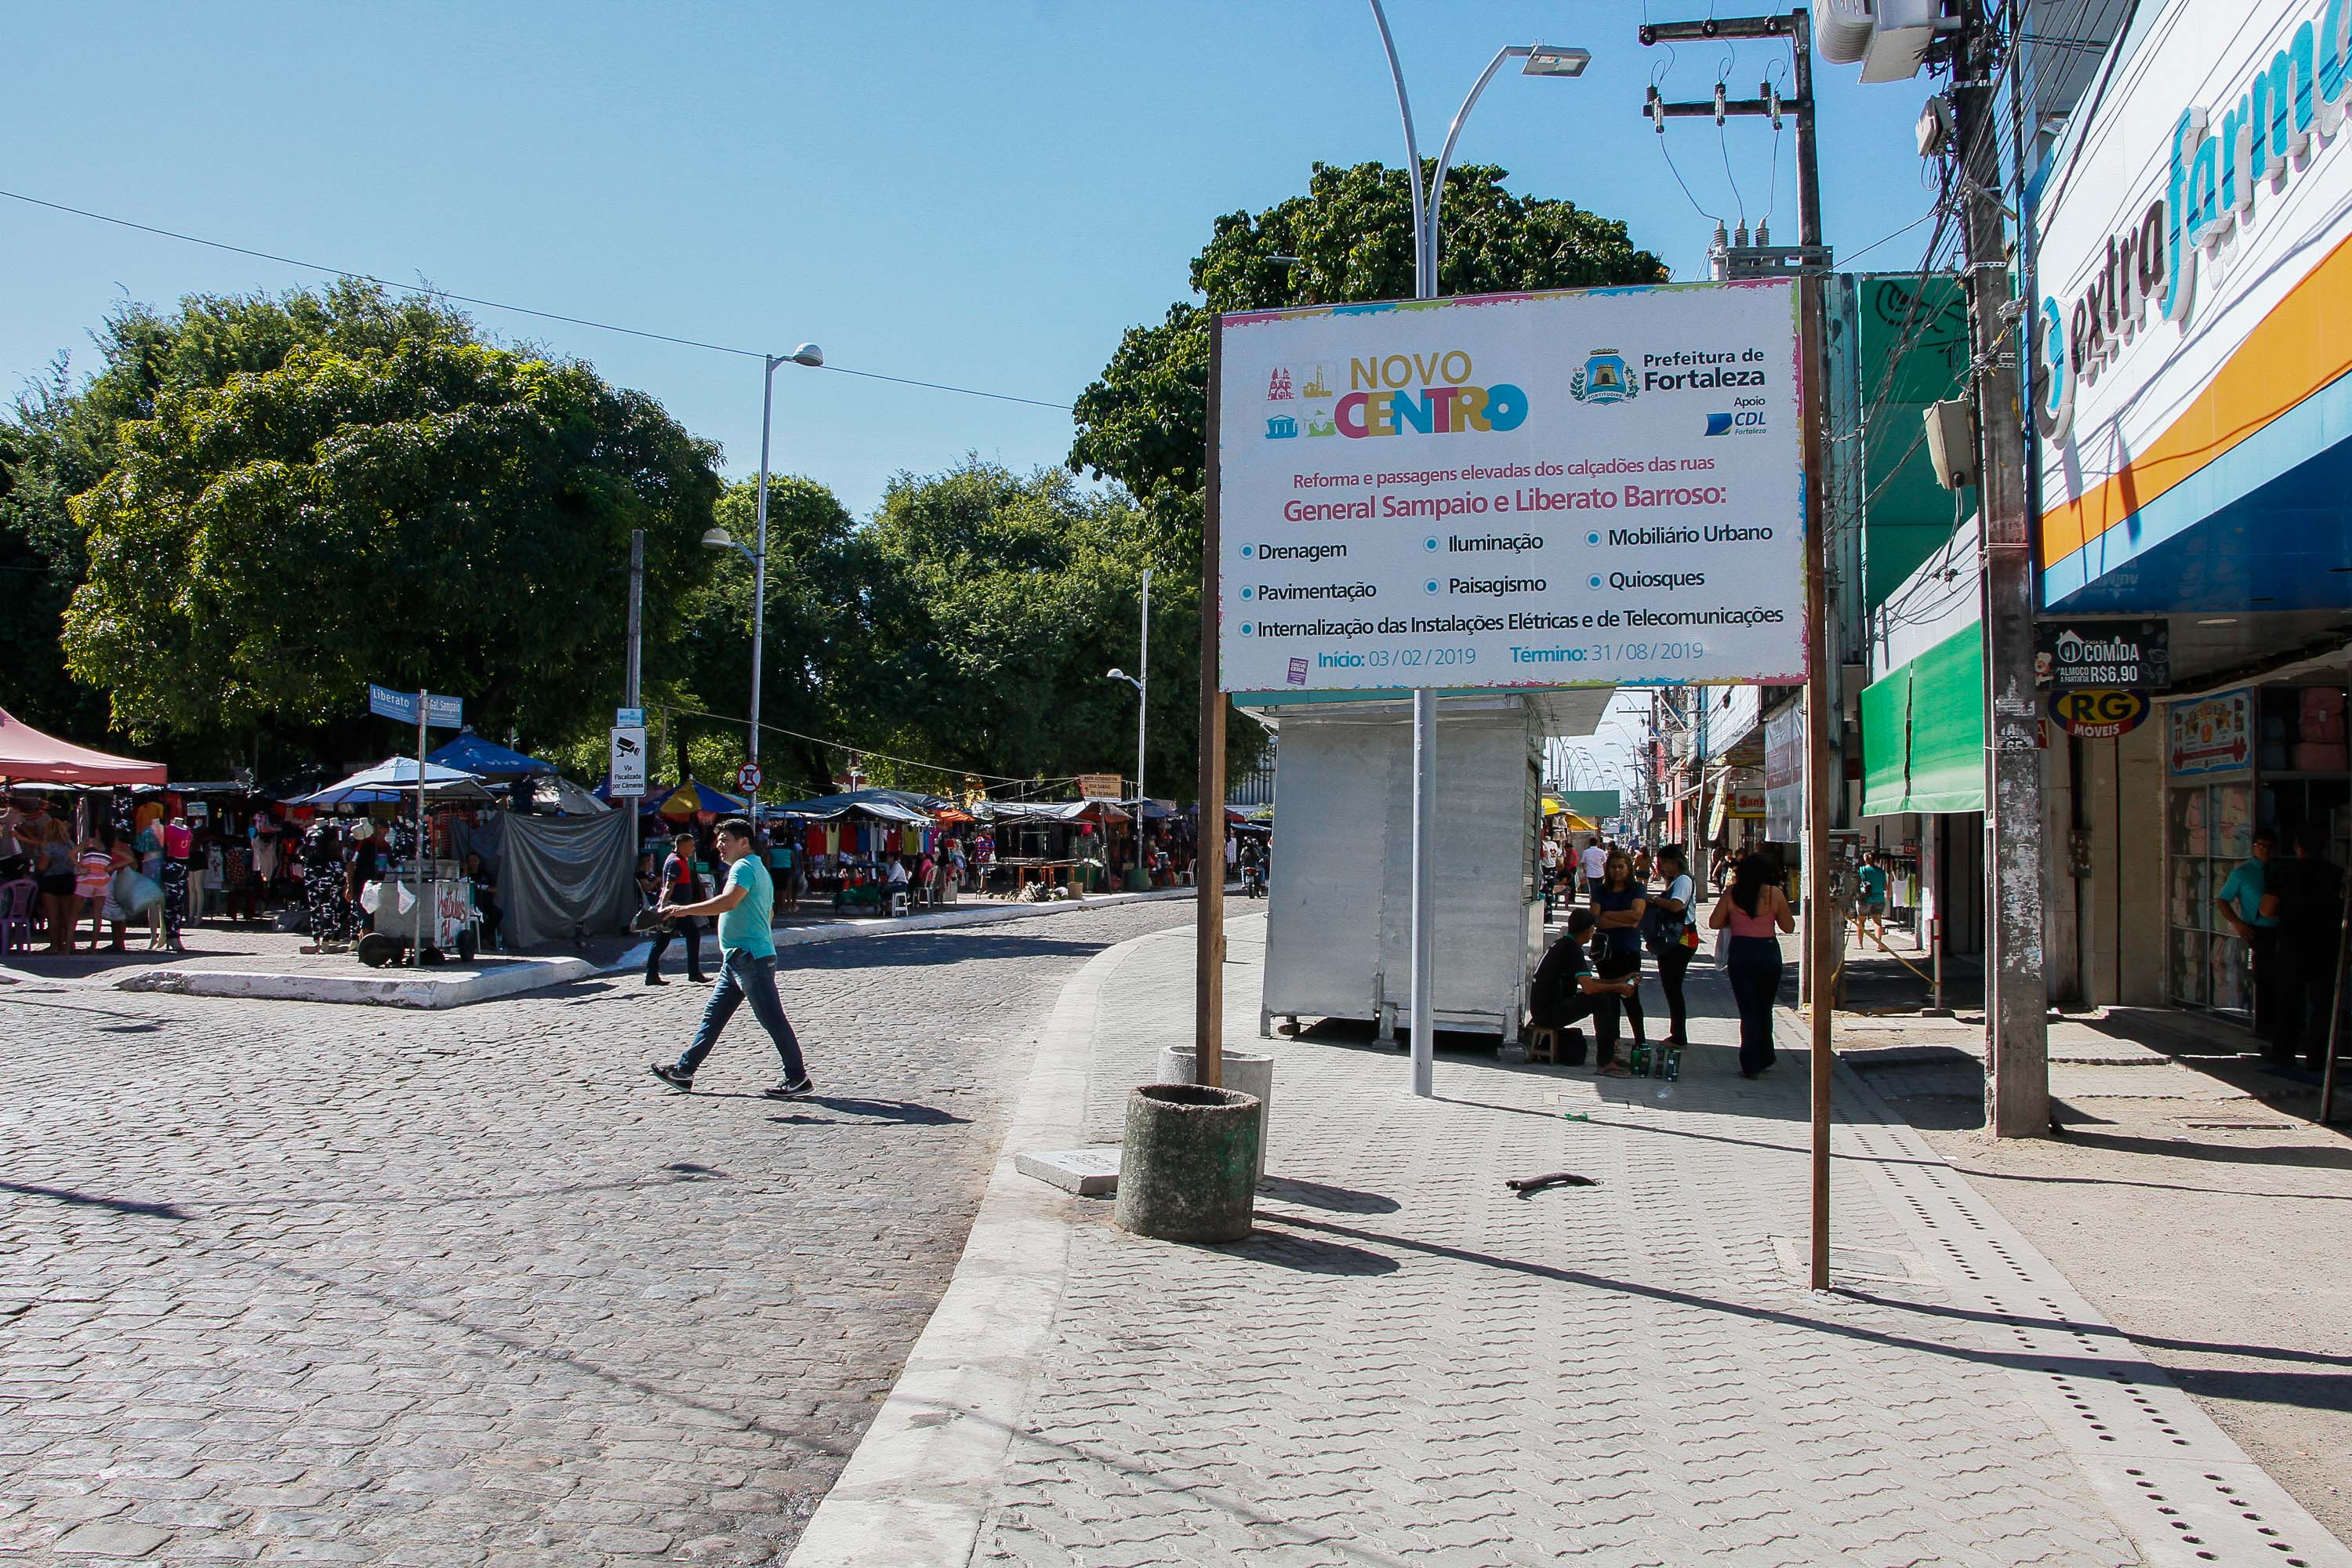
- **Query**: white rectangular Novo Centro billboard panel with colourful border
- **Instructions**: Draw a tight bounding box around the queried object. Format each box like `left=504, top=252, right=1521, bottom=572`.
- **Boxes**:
left=1214, top=282, right=1806, bottom=691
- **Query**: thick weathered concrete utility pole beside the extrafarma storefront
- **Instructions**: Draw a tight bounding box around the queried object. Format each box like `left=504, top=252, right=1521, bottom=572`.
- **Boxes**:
left=1952, top=0, right=2051, bottom=1138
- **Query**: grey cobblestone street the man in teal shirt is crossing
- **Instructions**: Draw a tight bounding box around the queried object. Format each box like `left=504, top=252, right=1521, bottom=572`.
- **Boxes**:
left=0, top=902, right=1192, bottom=1568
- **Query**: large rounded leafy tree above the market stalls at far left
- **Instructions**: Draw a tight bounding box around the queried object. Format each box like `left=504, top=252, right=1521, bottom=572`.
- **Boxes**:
left=64, top=321, right=720, bottom=755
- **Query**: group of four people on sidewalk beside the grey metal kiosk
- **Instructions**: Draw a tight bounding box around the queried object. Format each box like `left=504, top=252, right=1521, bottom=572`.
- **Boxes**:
left=1529, top=841, right=1797, bottom=1079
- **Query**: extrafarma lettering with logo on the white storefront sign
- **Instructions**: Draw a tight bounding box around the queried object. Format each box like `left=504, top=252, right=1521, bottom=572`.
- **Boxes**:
left=2034, top=0, right=2352, bottom=442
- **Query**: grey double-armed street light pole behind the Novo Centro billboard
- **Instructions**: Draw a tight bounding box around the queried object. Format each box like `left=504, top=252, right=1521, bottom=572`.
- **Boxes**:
left=1371, top=0, right=1592, bottom=1100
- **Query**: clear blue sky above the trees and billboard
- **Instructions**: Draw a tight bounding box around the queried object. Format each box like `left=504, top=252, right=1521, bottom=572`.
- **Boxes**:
left=0, top=0, right=1929, bottom=526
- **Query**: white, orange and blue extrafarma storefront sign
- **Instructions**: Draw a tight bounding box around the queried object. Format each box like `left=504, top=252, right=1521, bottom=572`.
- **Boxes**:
left=2034, top=0, right=2352, bottom=602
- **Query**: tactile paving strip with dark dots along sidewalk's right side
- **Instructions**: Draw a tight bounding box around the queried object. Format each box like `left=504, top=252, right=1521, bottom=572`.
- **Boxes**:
left=1837, top=1067, right=2352, bottom=1568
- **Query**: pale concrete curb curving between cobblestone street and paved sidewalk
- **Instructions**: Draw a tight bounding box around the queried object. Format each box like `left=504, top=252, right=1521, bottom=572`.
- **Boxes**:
left=788, top=926, right=1167, bottom=1568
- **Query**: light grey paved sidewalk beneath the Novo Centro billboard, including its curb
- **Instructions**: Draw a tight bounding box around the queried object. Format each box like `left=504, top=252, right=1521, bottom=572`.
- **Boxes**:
left=795, top=916, right=2352, bottom=1568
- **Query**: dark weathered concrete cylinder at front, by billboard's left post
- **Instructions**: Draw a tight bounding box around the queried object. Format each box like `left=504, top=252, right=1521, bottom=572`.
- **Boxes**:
left=1117, top=1083, right=1261, bottom=1241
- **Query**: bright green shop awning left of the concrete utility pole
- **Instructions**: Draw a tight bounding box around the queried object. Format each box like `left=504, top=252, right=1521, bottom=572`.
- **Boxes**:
left=1863, top=626, right=1985, bottom=815
